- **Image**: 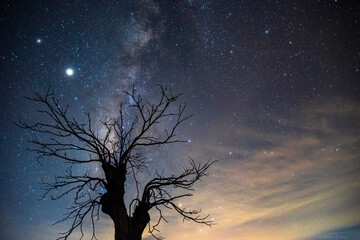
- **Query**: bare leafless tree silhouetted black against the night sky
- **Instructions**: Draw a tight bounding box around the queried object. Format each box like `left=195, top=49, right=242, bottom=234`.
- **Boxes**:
left=17, top=86, right=214, bottom=240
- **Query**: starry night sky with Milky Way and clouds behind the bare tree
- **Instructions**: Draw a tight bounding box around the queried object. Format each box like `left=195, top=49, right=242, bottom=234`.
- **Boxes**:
left=0, top=0, right=360, bottom=240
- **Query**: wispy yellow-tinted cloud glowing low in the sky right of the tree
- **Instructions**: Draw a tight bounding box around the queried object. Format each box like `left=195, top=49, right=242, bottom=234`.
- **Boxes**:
left=144, top=99, right=360, bottom=240
